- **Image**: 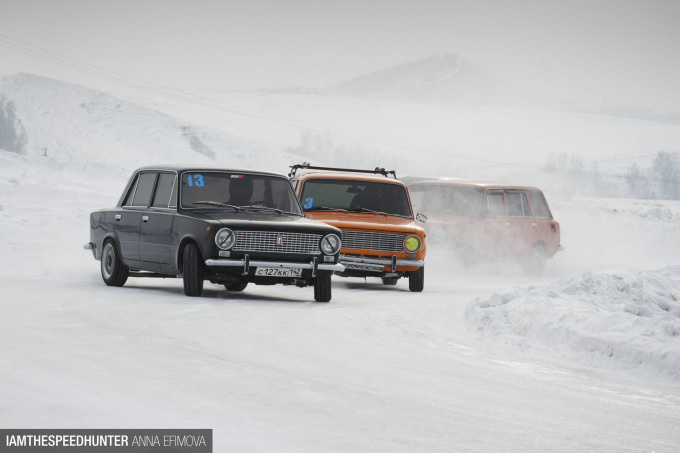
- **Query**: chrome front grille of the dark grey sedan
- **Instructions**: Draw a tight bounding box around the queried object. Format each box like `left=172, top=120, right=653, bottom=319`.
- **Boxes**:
left=233, top=230, right=321, bottom=255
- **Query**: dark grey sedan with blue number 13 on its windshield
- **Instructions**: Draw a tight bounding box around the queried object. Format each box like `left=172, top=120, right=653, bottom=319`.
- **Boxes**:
left=85, top=167, right=344, bottom=302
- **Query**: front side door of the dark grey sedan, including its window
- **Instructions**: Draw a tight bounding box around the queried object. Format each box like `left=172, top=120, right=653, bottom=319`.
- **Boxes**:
left=139, top=172, right=177, bottom=271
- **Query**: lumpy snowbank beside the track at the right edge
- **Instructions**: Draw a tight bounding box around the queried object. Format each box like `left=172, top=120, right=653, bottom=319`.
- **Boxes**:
left=465, top=266, right=680, bottom=378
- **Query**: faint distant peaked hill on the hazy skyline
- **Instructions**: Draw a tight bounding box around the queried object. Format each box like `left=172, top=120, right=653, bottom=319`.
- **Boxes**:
left=329, top=54, right=544, bottom=108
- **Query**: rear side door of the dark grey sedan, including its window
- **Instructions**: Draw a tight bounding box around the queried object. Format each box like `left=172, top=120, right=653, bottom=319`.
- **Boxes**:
left=113, top=172, right=156, bottom=265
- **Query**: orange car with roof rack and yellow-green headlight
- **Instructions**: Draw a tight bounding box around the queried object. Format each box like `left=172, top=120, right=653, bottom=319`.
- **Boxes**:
left=289, top=164, right=426, bottom=292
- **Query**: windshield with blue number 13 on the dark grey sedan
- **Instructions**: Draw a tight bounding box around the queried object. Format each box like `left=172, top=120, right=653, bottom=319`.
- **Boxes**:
left=180, top=171, right=302, bottom=215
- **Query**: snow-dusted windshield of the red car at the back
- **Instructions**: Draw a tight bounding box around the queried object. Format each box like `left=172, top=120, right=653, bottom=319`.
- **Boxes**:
left=408, top=184, right=482, bottom=215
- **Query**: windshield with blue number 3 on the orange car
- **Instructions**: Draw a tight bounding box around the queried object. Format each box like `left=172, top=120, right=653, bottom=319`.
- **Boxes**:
left=300, top=179, right=413, bottom=217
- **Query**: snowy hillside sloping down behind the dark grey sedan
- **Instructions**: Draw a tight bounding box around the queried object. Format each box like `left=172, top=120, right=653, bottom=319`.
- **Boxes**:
left=0, top=73, right=291, bottom=168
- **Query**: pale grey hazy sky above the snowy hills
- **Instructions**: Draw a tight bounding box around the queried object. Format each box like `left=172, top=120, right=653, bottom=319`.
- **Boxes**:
left=0, top=0, right=680, bottom=111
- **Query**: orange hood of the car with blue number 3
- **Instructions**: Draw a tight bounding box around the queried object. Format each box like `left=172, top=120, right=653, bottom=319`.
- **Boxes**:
left=305, top=212, right=423, bottom=234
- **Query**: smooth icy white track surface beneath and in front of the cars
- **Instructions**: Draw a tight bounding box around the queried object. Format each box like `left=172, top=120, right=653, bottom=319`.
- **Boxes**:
left=0, top=260, right=680, bottom=452
